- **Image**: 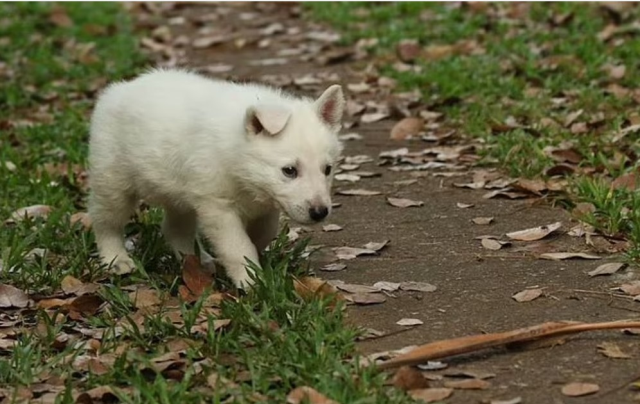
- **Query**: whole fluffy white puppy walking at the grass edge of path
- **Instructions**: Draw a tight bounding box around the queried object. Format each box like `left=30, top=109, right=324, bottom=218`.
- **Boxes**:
left=89, top=70, right=344, bottom=287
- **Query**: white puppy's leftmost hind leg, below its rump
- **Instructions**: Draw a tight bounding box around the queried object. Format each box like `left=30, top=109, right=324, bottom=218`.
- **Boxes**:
left=89, top=188, right=136, bottom=274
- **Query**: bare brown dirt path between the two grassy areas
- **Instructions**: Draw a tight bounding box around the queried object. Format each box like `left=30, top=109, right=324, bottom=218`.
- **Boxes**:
left=145, top=4, right=640, bottom=403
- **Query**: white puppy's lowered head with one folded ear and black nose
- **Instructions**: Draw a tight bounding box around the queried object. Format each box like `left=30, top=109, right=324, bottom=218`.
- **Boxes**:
left=241, top=85, right=345, bottom=223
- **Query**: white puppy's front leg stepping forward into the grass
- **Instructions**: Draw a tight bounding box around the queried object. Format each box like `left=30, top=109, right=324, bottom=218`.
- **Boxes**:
left=198, top=206, right=260, bottom=288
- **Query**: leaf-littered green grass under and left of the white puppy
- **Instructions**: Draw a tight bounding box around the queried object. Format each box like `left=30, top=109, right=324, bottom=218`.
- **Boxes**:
left=0, top=3, right=410, bottom=404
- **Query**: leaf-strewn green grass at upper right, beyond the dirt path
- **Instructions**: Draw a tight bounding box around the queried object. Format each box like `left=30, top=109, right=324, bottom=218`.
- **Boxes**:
left=305, top=2, right=640, bottom=259
